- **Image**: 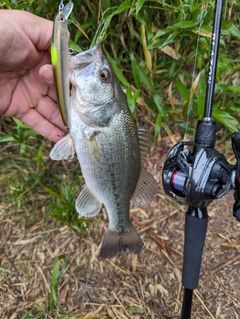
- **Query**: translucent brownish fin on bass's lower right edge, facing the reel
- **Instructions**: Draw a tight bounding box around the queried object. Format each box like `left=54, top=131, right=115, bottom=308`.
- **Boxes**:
left=132, top=167, right=158, bottom=207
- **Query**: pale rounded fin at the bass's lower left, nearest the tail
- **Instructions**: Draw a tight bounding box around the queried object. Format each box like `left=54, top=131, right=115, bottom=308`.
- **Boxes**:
left=75, top=184, right=102, bottom=217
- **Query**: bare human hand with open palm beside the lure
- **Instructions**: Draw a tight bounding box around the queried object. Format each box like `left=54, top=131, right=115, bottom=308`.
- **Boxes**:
left=0, top=10, right=64, bottom=142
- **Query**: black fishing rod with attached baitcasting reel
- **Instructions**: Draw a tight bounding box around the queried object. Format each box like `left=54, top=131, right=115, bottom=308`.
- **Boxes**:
left=162, top=0, right=240, bottom=319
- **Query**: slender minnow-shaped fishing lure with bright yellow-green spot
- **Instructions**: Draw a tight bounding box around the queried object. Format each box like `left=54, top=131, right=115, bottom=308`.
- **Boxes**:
left=51, top=2, right=73, bottom=128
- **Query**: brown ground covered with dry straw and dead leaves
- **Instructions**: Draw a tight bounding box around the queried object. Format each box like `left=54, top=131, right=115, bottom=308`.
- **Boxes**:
left=0, top=138, right=240, bottom=319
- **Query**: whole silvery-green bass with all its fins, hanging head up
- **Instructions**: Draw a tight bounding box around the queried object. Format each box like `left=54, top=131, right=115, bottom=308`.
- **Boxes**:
left=50, top=44, right=158, bottom=258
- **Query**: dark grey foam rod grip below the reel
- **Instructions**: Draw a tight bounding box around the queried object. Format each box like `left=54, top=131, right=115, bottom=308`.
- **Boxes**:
left=182, top=214, right=208, bottom=290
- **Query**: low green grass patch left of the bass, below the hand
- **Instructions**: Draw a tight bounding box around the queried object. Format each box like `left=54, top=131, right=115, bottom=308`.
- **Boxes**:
left=0, top=119, right=88, bottom=235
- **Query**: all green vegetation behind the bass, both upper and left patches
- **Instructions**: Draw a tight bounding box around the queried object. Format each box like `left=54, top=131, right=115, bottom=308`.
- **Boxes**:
left=0, top=0, right=240, bottom=318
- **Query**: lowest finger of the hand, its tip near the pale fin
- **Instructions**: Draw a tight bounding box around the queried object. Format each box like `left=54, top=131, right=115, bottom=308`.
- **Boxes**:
left=18, top=109, right=65, bottom=142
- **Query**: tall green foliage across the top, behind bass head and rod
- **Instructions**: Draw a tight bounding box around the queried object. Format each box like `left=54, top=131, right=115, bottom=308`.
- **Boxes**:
left=3, top=0, right=240, bottom=136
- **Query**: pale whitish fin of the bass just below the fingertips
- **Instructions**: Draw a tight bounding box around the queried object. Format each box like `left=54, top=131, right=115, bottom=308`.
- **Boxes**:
left=50, top=134, right=75, bottom=161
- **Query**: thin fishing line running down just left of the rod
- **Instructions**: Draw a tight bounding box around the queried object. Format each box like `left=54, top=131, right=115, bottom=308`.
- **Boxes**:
left=183, top=0, right=205, bottom=140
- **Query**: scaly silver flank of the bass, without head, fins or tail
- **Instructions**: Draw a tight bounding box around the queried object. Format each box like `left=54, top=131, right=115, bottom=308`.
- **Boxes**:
left=70, top=97, right=141, bottom=233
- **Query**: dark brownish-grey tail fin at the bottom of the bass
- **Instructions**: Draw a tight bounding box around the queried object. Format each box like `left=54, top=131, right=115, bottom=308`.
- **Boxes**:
left=100, top=225, right=143, bottom=258
